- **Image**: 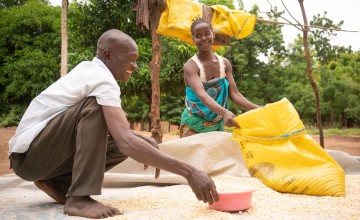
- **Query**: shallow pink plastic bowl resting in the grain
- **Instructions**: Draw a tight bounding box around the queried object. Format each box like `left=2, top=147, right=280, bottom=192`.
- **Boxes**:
left=209, top=190, right=255, bottom=212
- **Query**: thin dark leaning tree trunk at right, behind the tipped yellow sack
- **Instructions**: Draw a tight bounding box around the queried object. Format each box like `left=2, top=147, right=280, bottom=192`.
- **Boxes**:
left=298, top=0, right=325, bottom=148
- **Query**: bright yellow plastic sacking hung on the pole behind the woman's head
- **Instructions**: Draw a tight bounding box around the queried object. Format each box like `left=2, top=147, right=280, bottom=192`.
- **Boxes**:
left=156, top=0, right=256, bottom=44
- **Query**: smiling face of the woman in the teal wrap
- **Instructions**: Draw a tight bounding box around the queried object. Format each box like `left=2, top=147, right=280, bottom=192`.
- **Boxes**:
left=193, top=22, right=214, bottom=51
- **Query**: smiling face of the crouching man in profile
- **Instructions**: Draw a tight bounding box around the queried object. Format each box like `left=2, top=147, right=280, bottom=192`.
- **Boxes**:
left=106, top=44, right=139, bottom=82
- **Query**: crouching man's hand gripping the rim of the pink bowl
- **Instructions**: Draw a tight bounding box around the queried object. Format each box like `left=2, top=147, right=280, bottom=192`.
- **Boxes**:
left=187, top=169, right=219, bottom=204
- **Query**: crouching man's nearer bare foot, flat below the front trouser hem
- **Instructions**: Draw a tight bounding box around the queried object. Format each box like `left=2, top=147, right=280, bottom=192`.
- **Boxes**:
left=64, top=196, right=122, bottom=218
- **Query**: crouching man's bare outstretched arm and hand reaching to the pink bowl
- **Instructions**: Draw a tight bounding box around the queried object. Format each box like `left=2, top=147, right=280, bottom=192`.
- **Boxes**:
left=102, top=106, right=219, bottom=204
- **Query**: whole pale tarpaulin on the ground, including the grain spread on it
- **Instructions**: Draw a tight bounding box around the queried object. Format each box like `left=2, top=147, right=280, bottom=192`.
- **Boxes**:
left=0, top=132, right=360, bottom=219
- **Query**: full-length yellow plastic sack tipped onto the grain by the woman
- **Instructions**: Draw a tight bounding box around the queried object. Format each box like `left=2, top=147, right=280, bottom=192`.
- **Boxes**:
left=232, top=98, right=345, bottom=196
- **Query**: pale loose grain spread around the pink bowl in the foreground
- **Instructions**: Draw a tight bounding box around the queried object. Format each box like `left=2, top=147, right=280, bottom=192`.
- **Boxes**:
left=104, top=175, right=360, bottom=220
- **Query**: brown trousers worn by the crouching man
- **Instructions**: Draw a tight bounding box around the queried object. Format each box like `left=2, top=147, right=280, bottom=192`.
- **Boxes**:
left=10, top=97, right=127, bottom=196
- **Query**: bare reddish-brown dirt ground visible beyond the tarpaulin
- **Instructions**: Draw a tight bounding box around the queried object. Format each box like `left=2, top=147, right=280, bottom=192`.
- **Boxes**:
left=0, top=127, right=360, bottom=175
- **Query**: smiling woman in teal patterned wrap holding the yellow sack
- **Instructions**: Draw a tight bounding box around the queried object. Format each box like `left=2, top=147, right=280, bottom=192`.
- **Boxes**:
left=180, top=18, right=260, bottom=137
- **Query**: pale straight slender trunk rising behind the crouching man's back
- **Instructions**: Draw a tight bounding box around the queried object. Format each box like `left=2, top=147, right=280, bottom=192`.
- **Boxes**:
left=60, top=0, right=68, bottom=76
